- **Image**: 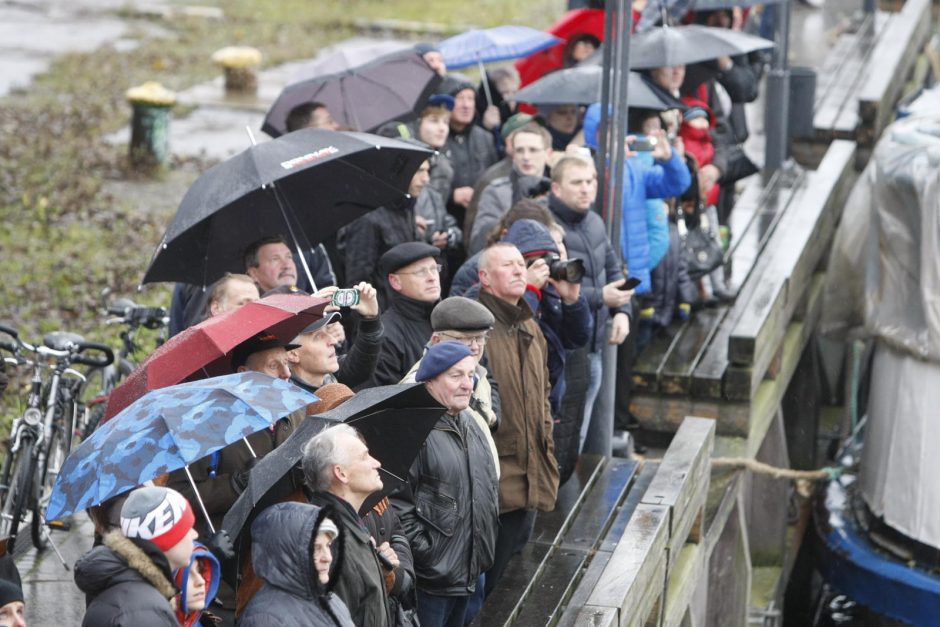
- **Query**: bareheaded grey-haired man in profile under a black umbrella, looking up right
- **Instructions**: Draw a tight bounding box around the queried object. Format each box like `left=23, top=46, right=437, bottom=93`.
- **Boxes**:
left=301, top=424, right=399, bottom=627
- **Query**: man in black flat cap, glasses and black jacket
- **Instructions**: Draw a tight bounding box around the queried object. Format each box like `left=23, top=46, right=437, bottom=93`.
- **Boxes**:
left=371, top=242, right=441, bottom=386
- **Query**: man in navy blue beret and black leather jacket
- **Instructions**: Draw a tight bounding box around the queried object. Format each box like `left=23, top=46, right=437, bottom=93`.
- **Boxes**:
left=392, top=342, right=499, bottom=627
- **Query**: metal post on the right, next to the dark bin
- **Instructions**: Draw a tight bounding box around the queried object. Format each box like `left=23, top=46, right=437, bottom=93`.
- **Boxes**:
left=764, top=2, right=790, bottom=174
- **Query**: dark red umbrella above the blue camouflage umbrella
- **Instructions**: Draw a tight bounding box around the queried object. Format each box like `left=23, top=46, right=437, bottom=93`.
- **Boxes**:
left=104, top=294, right=330, bottom=420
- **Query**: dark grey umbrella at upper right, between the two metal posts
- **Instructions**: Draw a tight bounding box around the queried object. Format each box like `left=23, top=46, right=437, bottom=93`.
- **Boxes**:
left=630, top=24, right=774, bottom=70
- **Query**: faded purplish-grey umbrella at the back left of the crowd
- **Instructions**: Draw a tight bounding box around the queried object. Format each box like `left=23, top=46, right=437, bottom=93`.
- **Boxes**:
left=261, top=50, right=441, bottom=137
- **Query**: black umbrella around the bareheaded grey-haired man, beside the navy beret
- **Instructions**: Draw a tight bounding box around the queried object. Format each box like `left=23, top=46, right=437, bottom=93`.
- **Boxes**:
left=222, top=383, right=444, bottom=538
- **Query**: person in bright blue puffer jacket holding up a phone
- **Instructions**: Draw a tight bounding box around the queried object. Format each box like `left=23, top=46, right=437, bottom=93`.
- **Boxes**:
left=584, top=103, right=692, bottom=294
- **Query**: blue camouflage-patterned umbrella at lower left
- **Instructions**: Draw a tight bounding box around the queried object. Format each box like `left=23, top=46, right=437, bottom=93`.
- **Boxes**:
left=46, top=372, right=319, bottom=520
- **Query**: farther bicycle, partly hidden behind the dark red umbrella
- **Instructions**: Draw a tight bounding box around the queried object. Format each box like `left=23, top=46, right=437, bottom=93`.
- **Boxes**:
left=79, top=288, right=170, bottom=437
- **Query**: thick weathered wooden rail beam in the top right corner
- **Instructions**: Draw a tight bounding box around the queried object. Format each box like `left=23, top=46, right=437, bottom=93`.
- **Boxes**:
left=857, top=0, right=931, bottom=146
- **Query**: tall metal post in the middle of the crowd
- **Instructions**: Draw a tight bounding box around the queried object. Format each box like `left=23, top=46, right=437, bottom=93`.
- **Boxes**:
left=583, top=0, right=633, bottom=457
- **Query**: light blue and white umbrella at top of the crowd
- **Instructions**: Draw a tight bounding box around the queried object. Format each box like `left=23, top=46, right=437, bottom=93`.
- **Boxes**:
left=438, top=25, right=562, bottom=70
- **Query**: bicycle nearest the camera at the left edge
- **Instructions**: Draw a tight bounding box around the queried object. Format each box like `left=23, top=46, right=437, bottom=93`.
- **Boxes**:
left=0, top=326, right=114, bottom=559
